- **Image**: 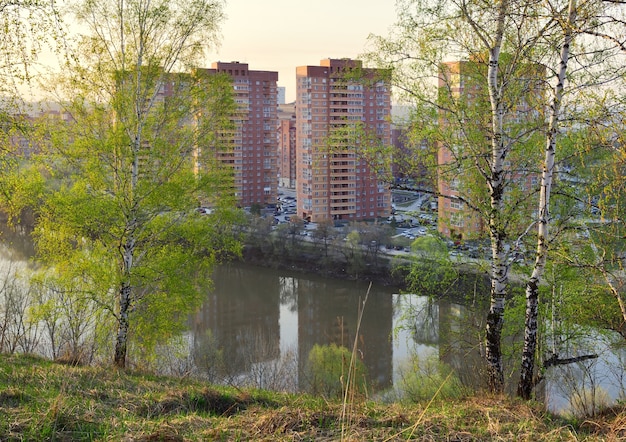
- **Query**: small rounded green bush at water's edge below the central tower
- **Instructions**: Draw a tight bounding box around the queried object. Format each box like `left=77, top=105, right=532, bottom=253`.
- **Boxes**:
left=307, top=344, right=367, bottom=398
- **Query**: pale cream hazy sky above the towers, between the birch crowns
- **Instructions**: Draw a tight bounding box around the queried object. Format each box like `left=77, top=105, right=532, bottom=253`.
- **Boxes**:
left=208, top=0, right=396, bottom=102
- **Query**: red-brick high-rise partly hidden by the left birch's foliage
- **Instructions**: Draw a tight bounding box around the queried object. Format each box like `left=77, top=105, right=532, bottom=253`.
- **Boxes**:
left=200, top=61, right=278, bottom=207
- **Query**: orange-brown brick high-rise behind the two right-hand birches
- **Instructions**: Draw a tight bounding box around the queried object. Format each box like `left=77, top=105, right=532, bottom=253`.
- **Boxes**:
left=437, top=59, right=545, bottom=239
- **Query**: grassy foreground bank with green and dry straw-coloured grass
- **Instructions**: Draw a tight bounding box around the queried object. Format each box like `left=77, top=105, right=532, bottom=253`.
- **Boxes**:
left=0, top=355, right=626, bottom=441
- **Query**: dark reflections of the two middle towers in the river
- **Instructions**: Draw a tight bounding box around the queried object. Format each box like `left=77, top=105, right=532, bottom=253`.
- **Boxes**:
left=192, top=264, right=393, bottom=386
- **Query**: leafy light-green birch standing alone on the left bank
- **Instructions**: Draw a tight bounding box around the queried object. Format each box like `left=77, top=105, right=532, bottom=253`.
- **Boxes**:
left=35, top=0, right=239, bottom=368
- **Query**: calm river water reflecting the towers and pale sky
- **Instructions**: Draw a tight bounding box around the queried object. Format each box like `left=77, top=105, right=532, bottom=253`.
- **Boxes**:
left=0, top=224, right=626, bottom=412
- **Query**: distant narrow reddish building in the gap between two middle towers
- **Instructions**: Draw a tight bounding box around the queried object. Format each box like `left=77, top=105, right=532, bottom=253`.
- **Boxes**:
left=278, top=103, right=296, bottom=189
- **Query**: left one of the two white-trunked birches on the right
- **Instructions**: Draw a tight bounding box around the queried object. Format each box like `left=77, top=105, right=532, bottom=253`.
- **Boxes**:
left=371, top=0, right=552, bottom=391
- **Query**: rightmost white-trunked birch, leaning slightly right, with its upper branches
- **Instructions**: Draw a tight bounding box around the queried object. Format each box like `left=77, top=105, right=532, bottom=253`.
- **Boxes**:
left=517, top=0, right=626, bottom=399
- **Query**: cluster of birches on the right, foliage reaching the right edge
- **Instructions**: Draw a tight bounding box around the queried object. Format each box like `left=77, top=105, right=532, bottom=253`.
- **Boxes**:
left=369, top=0, right=626, bottom=398
